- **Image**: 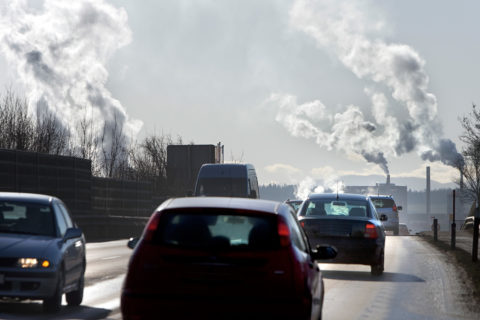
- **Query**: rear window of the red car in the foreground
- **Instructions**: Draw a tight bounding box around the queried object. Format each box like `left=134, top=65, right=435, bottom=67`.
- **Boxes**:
left=154, top=211, right=279, bottom=250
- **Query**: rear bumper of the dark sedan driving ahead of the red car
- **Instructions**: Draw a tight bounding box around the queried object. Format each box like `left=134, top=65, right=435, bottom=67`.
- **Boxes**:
left=310, top=237, right=385, bottom=265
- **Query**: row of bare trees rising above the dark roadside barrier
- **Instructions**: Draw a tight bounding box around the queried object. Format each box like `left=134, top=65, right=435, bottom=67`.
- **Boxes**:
left=0, top=90, right=182, bottom=181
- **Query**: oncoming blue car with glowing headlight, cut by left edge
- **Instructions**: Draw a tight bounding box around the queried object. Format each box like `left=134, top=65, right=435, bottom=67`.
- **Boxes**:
left=0, top=192, right=86, bottom=312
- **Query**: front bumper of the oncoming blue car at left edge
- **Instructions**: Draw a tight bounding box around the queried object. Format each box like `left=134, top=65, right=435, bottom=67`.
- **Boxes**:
left=0, top=269, right=57, bottom=299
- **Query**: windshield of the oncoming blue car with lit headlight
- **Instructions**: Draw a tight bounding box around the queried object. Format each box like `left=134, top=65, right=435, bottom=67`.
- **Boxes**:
left=0, top=201, right=56, bottom=237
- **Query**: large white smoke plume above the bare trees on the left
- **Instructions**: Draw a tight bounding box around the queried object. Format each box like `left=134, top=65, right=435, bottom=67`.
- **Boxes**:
left=0, top=0, right=142, bottom=154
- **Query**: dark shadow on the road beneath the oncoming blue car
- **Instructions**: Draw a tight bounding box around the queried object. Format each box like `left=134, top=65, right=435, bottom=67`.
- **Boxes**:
left=0, top=302, right=111, bottom=320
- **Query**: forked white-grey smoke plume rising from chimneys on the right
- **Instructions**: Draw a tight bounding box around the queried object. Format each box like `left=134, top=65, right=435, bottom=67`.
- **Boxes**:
left=268, top=0, right=462, bottom=173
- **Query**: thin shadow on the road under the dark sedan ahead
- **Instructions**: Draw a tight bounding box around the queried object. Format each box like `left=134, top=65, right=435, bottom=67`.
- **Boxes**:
left=322, top=270, right=425, bottom=282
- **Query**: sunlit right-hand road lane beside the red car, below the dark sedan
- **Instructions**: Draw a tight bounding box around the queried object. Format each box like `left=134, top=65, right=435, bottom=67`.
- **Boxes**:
left=320, top=236, right=480, bottom=320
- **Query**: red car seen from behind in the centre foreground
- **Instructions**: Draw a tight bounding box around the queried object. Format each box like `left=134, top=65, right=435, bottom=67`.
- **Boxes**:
left=121, top=197, right=336, bottom=319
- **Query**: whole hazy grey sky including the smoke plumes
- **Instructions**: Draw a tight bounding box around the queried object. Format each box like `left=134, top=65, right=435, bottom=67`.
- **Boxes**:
left=0, top=0, right=480, bottom=189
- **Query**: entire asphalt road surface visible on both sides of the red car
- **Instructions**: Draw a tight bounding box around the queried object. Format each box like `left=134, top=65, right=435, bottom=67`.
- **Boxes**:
left=0, top=236, right=480, bottom=320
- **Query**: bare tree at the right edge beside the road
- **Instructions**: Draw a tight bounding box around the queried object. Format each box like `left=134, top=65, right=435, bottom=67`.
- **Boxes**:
left=457, top=104, right=480, bottom=203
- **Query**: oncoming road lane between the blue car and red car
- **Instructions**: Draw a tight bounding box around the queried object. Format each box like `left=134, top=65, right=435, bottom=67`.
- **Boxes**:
left=0, top=239, right=132, bottom=320
